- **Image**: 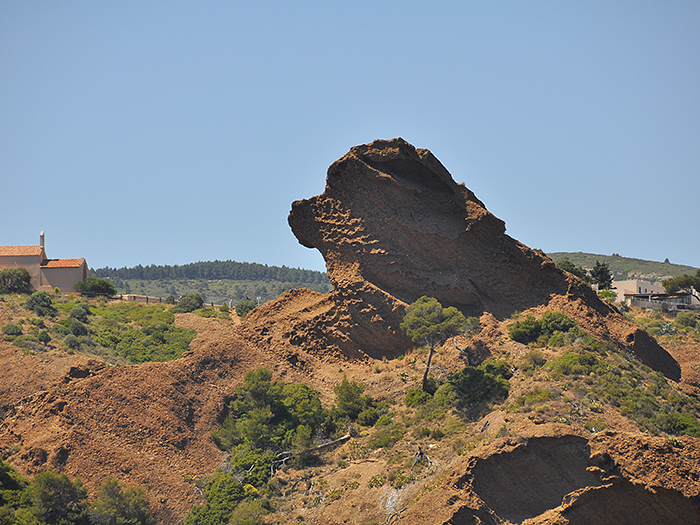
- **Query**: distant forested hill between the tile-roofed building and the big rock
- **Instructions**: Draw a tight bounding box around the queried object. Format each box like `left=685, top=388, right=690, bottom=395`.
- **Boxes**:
left=90, top=261, right=333, bottom=304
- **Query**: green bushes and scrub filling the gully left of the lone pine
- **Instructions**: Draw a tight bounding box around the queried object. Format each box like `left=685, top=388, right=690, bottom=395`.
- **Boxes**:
left=186, top=359, right=512, bottom=525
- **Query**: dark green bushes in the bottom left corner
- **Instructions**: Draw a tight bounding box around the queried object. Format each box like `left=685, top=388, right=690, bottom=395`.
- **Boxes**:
left=0, top=459, right=156, bottom=525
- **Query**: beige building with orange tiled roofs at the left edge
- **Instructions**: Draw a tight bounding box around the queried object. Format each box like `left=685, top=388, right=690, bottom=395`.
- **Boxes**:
left=0, top=232, right=88, bottom=291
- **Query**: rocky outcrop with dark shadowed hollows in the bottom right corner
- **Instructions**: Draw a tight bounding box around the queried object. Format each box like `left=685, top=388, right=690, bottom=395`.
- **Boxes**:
left=402, top=426, right=700, bottom=525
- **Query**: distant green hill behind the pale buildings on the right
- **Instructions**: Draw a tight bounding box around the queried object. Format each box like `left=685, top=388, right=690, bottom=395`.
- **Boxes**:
left=547, top=252, right=698, bottom=282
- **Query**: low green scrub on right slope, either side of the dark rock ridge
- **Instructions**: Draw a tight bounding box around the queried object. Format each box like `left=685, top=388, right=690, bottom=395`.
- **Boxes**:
left=509, top=312, right=700, bottom=437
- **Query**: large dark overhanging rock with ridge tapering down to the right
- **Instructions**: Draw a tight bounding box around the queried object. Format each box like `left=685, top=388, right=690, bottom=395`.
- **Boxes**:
left=289, top=138, right=680, bottom=381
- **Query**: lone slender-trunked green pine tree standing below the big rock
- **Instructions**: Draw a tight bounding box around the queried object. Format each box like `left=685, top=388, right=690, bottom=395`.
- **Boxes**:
left=401, top=295, right=467, bottom=392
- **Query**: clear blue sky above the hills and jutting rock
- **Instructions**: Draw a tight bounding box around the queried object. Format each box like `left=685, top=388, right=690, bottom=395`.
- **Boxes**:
left=0, top=0, right=700, bottom=270
